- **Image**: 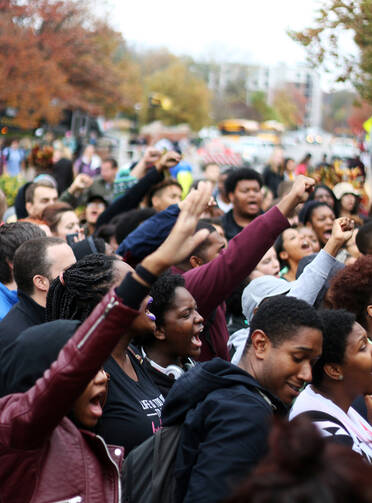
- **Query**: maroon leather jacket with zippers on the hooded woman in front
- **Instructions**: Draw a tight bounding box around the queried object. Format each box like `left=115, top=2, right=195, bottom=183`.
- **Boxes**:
left=0, top=291, right=138, bottom=503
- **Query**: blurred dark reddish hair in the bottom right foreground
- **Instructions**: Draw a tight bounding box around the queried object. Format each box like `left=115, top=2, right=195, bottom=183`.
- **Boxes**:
left=226, top=416, right=372, bottom=503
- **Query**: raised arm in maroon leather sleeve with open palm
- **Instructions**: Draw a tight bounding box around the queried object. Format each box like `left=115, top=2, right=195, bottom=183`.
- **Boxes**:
left=0, top=180, right=209, bottom=449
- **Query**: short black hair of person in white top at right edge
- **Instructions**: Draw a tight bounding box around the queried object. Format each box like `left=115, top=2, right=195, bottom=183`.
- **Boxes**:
left=312, top=309, right=356, bottom=386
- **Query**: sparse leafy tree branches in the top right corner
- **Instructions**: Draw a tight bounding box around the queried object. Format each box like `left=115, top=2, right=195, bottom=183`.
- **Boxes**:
left=289, top=0, right=372, bottom=103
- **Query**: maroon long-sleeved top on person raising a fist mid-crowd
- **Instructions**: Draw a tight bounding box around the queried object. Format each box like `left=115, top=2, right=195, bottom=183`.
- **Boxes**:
left=177, top=206, right=289, bottom=361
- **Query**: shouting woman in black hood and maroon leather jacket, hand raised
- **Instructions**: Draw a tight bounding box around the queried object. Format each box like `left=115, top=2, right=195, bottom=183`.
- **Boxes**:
left=0, top=179, right=211, bottom=503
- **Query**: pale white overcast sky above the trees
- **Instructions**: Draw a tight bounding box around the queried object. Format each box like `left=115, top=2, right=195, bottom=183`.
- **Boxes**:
left=106, top=0, right=352, bottom=87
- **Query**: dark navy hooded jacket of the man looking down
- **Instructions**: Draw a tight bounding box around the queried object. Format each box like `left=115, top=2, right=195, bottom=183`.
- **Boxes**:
left=162, top=358, right=286, bottom=503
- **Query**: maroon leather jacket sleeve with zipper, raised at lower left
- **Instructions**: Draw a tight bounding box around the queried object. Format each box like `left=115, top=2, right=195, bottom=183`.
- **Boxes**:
left=0, top=291, right=138, bottom=449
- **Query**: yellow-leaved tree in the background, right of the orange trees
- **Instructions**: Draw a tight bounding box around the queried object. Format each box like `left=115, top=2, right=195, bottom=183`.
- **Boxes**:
left=142, top=59, right=210, bottom=130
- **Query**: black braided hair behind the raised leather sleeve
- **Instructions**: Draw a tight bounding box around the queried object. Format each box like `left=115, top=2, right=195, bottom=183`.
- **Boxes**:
left=46, top=253, right=121, bottom=321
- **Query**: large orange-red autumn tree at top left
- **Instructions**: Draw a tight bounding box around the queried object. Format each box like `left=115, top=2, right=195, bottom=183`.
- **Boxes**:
left=0, top=0, right=140, bottom=127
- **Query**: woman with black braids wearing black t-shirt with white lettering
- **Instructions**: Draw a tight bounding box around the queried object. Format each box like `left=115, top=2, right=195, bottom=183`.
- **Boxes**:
left=42, top=183, right=212, bottom=453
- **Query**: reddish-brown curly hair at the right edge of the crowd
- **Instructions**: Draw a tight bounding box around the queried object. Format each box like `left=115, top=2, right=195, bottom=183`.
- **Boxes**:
left=327, top=255, right=372, bottom=329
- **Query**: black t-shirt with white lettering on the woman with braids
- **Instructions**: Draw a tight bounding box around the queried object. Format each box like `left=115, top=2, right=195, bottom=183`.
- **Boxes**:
left=97, top=351, right=164, bottom=455
